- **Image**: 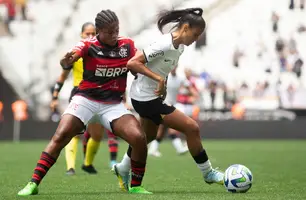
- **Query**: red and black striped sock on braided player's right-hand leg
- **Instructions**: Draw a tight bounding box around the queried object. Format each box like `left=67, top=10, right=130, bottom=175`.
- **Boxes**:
left=131, top=160, right=146, bottom=187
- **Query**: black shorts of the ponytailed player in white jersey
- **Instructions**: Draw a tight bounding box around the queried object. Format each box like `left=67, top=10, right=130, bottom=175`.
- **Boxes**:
left=132, top=98, right=175, bottom=125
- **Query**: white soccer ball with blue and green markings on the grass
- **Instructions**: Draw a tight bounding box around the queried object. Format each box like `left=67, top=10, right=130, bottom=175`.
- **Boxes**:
left=224, top=164, right=253, bottom=193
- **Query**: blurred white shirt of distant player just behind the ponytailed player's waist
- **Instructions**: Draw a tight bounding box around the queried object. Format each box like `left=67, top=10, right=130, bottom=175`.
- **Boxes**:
left=165, top=74, right=184, bottom=105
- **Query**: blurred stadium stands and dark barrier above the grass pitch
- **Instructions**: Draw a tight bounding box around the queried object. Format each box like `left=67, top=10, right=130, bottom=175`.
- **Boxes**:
left=0, top=0, right=306, bottom=139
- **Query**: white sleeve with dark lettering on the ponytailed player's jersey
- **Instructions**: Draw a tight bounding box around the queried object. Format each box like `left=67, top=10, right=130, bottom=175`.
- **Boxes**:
left=143, top=37, right=171, bottom=62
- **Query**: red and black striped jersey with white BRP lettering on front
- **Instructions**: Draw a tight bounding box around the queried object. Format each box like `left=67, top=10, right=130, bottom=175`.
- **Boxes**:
left=73, top=37, right=136, bottom=103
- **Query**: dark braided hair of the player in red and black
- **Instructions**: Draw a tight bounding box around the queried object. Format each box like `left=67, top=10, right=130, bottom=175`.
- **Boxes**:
left=95, top=10, right=119, bottom=29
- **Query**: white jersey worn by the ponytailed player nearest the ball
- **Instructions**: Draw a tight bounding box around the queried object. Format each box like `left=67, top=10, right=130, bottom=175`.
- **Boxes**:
left=130, top=33, right=184, bottom=101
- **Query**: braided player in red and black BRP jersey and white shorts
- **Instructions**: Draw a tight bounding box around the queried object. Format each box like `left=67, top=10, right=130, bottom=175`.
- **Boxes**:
left=18, top=10, right=151, bottom=196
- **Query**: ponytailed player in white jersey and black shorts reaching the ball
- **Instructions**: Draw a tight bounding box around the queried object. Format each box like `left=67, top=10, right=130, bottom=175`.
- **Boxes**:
left=113, top=8, right=224, bottom=191
